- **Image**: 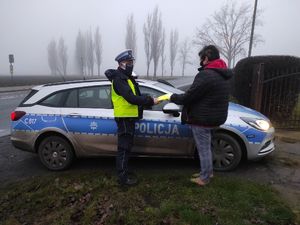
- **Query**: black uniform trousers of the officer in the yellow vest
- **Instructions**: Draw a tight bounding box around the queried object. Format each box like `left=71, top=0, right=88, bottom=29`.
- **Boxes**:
left=115, top=118, right=136, bottom=183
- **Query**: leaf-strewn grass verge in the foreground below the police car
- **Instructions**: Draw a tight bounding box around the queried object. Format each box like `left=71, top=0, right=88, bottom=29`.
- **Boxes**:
left=0, top=170, right=296, bottom=225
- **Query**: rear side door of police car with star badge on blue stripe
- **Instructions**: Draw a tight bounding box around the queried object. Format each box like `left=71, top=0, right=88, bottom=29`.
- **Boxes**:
left=62, top=85, right=117, bottom=155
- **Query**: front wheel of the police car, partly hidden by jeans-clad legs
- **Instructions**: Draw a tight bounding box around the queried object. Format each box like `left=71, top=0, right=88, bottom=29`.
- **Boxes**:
left=212, top=133, right=242, bottom=171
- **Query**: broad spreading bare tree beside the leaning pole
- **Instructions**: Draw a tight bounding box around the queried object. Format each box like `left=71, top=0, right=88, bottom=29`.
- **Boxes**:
left=195, top=1, right=262, bottom=67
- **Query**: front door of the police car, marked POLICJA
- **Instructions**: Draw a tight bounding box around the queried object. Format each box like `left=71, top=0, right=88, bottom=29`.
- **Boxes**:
left=133, top=85, right=194, bottom=156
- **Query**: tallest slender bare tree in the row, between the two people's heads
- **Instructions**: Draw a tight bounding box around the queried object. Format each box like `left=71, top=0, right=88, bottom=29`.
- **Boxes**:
left=150, top=6, right=163, bottom=77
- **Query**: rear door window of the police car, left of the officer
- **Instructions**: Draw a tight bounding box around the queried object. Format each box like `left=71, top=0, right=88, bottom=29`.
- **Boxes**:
left=78, top=85, right=112, bottom=109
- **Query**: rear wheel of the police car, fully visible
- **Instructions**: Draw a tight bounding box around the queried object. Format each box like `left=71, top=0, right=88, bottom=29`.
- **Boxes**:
left=38, top=136, right=74, bottom=171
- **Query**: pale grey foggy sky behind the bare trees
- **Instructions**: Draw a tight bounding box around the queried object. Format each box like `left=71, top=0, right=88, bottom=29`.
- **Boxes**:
left=0, top=0, right=300, bottom=75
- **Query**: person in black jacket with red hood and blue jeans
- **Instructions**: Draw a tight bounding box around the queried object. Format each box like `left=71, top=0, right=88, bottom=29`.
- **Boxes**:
left=170, top=45, right=232, bottom=186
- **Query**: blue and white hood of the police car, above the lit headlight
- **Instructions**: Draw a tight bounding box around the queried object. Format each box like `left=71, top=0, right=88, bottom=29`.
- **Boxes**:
left=229, top=102, right=269, bottom=120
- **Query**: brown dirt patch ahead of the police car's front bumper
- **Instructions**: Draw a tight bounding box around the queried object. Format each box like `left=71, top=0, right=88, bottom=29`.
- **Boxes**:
left=222, top=140, right=300, bottom=221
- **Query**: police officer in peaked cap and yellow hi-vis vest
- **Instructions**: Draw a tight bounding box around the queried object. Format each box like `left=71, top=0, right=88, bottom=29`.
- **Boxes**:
left=105, top=49, right=158, bottom=186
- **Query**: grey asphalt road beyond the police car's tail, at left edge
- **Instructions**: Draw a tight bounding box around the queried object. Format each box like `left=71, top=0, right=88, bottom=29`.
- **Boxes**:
left=0, top=91, right=28, bottom=137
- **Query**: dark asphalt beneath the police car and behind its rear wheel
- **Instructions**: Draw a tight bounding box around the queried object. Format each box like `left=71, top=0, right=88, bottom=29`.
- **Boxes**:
left=0, top=135, right=199, bottom=185
